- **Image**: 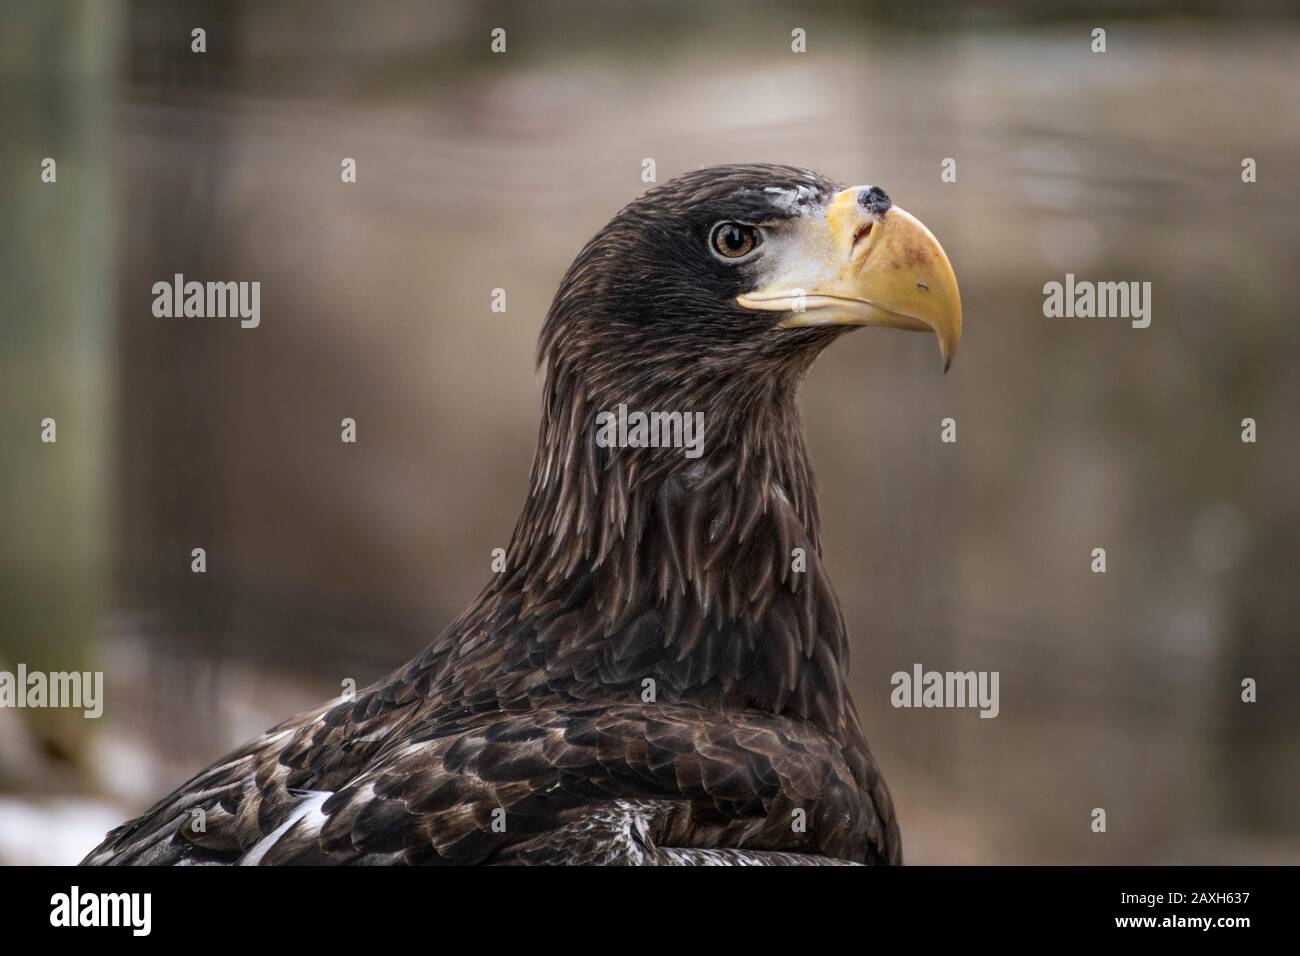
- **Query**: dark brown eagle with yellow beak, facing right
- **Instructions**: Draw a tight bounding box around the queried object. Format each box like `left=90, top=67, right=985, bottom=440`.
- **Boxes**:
left=85, top=164, right=962, bottom=865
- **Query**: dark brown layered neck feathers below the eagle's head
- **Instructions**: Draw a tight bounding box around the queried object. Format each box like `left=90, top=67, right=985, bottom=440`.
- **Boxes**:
left=462, top=353, right=857, bottom=737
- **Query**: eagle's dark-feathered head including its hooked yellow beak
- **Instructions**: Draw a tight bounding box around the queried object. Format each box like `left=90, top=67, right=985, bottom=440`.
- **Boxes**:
left=540, top=164, right=962, bottom=418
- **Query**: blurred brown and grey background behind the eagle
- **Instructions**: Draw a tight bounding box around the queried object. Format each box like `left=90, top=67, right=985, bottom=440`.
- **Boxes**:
left=0, top=0, right=1300, bottom=864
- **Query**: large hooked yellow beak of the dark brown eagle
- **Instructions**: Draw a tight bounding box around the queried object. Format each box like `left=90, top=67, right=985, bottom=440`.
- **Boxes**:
left=736, top=187, right=962, bottom=371
